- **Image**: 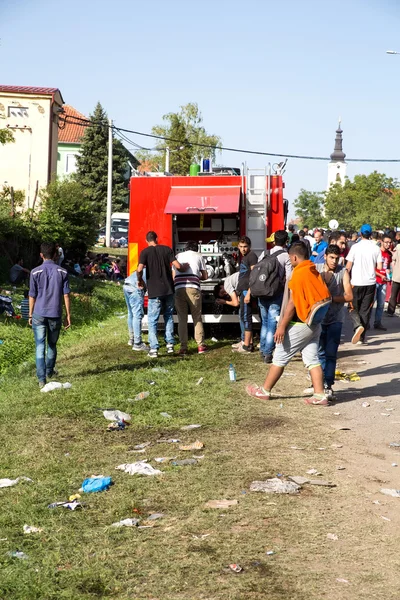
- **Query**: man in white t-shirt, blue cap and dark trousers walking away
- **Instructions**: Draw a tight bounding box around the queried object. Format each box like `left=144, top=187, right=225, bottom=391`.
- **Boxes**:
left=346, top=224, right=382, bottom=344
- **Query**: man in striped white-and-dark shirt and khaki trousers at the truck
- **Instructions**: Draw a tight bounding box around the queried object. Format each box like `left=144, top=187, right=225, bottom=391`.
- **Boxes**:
left=174, top=242, right=208, bottom=356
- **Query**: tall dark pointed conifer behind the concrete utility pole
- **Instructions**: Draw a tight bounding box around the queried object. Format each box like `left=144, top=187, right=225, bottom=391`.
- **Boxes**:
left=76, top=102, right=129, bottom=222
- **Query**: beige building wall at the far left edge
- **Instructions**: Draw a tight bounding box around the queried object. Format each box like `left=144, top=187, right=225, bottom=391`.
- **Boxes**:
left=0, top=91, right=62, bottom=208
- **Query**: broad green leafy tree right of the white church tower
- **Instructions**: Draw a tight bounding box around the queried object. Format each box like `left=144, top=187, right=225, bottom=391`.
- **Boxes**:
left=325, top=171, right=400, bottom=229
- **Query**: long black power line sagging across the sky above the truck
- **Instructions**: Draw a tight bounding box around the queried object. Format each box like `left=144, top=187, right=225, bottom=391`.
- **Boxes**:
left=58, top=116, right=400, bottom=163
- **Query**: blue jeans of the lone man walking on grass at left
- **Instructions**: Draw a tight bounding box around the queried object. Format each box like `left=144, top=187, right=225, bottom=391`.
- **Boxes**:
left=32, top=313, right=61, bottom=382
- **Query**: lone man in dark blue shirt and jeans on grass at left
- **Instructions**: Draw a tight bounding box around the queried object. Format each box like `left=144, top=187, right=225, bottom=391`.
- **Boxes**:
left=29, top=242, right=71, bottom=388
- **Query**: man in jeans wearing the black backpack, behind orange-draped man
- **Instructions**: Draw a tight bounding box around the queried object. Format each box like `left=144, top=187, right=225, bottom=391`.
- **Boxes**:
left=255, top=229, right=292, bottom=364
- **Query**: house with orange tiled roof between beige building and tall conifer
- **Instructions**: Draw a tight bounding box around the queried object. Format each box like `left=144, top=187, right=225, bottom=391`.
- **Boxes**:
left=57, top=104, right=87, bottom=177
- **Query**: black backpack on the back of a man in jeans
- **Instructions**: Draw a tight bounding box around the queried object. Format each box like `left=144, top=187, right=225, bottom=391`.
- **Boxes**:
left=250, top=249, right=286, bottom=298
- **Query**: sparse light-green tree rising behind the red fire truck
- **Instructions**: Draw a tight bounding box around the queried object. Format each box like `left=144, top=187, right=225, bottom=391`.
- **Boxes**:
left=137, top=102, right=222, bottom=175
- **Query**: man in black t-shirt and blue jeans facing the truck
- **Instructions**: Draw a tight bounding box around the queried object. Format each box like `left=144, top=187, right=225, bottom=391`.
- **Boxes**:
left=137, top=231, right=188, bottom=358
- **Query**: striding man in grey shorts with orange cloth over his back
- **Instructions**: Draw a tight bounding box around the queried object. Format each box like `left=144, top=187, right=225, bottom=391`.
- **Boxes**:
left=246, top=242, right=331, bottom=406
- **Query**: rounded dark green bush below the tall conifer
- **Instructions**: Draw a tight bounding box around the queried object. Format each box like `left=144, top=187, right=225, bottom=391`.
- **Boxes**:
left=36, top=179, right=98, bottom=252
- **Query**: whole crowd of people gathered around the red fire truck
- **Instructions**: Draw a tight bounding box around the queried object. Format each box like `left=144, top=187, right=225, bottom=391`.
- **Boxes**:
left=10, top=224, right=400, bottom=398
